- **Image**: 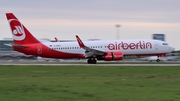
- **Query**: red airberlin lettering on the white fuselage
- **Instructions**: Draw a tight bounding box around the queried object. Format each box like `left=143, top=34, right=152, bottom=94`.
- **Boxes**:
left=107, top=41, right=152, bottom=50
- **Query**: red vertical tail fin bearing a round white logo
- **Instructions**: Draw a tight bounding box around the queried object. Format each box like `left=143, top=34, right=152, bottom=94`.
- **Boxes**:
left=6, top=13, right=39, bottom=44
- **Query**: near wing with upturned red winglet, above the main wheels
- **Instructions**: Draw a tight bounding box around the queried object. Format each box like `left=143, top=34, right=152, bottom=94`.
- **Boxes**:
left=76, top=35, right=106, bottom=57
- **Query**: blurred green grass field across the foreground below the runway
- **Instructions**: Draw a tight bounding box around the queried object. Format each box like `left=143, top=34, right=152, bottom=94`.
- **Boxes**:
left=0, top=66, right=180, bottom=101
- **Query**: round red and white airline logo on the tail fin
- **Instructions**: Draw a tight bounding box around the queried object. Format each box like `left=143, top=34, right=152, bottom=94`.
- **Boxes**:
left=9, top=19, right=26, bottom=41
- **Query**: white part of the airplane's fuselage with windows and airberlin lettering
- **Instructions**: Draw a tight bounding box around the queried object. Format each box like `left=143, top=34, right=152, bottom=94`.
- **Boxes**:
left=43, top=39, right=174, bottom=55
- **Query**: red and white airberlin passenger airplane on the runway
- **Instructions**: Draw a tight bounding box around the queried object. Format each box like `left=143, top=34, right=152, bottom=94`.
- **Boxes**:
left=6, top=13, right=175, bottom=64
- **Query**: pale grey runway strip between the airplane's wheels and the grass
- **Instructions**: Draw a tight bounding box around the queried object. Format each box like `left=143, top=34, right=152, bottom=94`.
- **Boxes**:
left=0, top=61, right=180, bottom=66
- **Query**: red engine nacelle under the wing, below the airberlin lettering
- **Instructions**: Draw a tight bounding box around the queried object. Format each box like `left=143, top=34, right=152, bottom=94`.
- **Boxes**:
left=104, top=52, right=123, bottom=61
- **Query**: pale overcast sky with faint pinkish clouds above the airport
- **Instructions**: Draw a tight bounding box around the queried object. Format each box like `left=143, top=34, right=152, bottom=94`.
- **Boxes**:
left=0, top=0, right=180, bottom=50
